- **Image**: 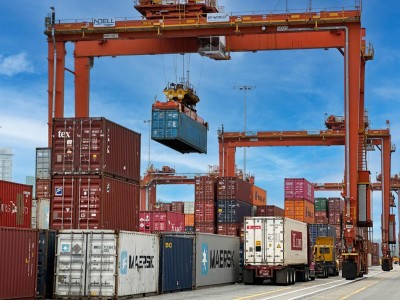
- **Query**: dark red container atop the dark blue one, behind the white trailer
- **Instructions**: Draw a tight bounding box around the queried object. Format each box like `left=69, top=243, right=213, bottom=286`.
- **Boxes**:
left=217, top=177, right=251, bottom=203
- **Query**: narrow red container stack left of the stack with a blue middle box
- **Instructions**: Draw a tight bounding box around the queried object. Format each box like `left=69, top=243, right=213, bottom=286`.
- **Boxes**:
left=194, top=176, right=216, bottom=233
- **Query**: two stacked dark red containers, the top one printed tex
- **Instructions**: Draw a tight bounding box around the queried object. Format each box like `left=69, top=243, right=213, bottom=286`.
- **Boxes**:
left=50, top=118, right=140, bottom=231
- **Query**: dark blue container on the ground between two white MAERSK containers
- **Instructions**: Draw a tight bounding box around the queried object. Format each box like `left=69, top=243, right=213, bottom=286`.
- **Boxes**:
left=159, top=235, right=195, bottom=293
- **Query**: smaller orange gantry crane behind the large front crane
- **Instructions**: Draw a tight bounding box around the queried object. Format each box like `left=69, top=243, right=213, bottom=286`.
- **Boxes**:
left=218, top=129, right=393, bottom=279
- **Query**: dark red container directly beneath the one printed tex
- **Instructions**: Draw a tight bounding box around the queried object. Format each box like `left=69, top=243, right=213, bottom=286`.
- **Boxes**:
left=50, top=175, right=139, bottom=231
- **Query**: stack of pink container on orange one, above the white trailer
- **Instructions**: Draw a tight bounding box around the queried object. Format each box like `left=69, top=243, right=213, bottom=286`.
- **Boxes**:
left=285, top=178, right=315, bottom=224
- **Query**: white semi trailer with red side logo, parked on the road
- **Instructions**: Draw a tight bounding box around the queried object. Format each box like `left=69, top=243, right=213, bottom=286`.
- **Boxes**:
left=243, top=217, right=315, bottom=285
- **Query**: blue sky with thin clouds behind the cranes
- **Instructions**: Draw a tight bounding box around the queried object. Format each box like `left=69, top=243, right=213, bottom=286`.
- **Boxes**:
left=0, top=0, right=400, bottom=247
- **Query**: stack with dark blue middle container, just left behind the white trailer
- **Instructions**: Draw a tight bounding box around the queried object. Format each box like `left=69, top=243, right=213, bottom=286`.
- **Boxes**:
left=217, top=177, right=253, bottom=236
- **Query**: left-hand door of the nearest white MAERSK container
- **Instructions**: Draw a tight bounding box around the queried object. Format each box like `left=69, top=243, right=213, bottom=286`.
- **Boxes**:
left=55, top=232, right=86, bottom=296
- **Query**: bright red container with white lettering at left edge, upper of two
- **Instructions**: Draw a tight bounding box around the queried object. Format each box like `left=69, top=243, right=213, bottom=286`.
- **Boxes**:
left=0, top=180, right=32, bottom=227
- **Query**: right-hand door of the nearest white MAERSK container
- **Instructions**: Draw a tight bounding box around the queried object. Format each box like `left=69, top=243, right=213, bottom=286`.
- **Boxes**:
left=86, top=232, right=117, bottom=297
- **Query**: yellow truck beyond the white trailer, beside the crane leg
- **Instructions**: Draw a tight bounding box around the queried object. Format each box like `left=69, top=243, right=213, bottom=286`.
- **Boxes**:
left=314, top=236, right=339, bottom=278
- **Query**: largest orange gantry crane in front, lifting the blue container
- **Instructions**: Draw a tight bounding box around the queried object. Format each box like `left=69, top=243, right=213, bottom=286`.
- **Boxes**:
left=45, top=0, right=382, bottom=278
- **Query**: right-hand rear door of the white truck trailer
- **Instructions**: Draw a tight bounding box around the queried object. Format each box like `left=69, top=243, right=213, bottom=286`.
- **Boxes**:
left=264, top=218, right=285, bottom=264
